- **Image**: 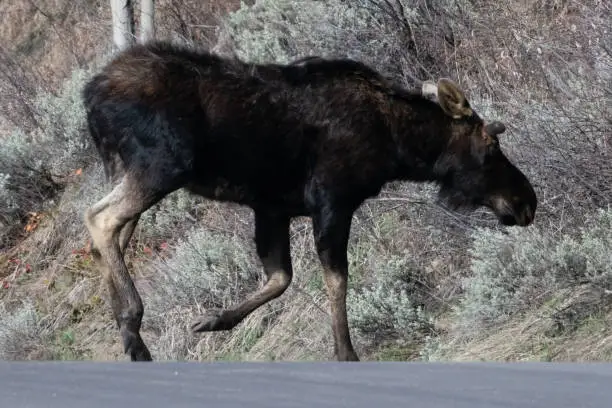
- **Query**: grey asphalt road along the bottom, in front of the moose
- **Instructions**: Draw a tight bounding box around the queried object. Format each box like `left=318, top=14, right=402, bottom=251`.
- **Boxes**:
left=0, top=362, right=612, bottom=408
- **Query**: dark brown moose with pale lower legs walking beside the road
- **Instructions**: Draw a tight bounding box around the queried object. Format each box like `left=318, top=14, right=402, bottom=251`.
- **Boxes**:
left=82, top=41, right=537, bottom=361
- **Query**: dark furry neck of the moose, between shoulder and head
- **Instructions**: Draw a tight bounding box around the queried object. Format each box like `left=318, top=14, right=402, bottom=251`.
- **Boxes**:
left=394, top=97, right=452, bottom=181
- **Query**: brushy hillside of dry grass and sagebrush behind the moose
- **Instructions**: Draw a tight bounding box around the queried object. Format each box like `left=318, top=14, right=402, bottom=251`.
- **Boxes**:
left=0, top=0, right=612, bottom=361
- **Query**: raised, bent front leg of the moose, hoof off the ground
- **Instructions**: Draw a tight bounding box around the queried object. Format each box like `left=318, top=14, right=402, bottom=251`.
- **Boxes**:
left=191, top=212, right=293, bottom=332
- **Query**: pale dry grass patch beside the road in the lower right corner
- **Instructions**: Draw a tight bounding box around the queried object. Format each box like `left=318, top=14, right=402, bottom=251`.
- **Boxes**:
left=427, top=287, right=612, bottom=362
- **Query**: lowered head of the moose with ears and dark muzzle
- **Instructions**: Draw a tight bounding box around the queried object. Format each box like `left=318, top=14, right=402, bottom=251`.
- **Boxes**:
left=422, top=78, right=537, bottom=226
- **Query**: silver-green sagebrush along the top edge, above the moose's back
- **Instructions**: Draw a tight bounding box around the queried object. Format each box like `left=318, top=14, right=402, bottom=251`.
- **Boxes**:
left=221, top=0, right=456, bottom=82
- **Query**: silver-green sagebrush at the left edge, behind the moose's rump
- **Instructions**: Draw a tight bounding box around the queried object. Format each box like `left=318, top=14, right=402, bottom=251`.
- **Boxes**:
left=0, top=69, right=93, bottom=242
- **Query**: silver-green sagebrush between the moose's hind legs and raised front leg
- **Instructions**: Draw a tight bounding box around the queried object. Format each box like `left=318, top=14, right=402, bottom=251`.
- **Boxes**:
left=143, top=227, right=260, bottom=360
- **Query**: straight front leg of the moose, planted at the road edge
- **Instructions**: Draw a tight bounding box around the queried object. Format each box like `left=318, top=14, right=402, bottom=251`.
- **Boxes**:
left=312, top=208, right=359, bottom=361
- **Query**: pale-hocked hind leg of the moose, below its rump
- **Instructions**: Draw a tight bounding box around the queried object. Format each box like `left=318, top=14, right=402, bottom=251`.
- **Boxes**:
left=85, top=174, right=176, bottom=361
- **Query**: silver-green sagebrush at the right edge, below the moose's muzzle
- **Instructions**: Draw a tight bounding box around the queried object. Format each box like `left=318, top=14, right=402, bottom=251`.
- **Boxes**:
left=457, top=209, right=612, bottom=330
